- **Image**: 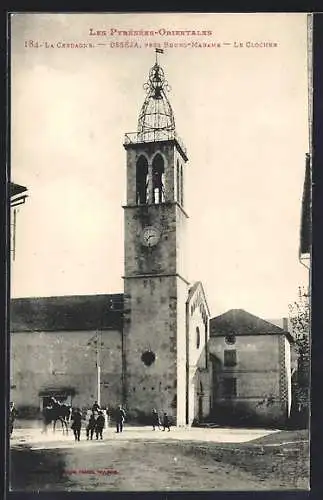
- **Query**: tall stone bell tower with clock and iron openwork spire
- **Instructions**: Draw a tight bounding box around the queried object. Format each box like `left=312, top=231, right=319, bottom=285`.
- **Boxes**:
left=123, top=51, right=189, bottom=425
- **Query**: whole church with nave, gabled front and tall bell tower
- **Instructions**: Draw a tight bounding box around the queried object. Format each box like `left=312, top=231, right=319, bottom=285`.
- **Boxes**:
left=11, top=54, right=210, bottom=425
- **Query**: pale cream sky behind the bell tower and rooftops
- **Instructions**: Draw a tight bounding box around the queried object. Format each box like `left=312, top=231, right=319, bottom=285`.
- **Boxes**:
left=11, top=13, right=309, bottom=318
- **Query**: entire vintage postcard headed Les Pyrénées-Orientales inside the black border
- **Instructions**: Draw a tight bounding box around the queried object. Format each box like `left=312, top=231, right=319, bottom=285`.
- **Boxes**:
left=8, top=12, right=312, bottom=492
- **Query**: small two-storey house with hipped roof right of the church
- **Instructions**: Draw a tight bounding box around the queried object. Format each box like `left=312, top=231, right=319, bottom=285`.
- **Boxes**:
left=209, top=309, right=293, bottom=425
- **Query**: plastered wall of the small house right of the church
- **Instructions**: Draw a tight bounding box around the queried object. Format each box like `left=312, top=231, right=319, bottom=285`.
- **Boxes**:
left=209, top=335, right=290, bottom=423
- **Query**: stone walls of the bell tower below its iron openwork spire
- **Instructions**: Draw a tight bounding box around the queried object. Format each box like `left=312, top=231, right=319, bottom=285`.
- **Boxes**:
left=124, top=141, right=188, bottom=425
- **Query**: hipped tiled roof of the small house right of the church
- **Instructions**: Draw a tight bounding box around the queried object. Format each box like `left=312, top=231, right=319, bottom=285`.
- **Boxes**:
left=210, top=309, right=293, bottom=341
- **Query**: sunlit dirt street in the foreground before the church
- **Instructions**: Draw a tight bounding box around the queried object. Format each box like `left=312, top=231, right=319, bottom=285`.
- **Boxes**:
left=11, top=428, right=308, bottom=491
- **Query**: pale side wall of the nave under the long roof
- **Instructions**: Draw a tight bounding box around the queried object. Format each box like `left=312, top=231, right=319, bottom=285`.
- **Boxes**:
left=10, top=330, right=122, bottom=412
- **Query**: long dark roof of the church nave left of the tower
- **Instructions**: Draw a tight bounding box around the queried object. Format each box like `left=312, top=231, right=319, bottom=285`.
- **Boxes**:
left=10, top=293, right=123, bottom=332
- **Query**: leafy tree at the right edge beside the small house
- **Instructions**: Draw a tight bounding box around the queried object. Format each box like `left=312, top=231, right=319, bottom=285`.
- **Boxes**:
left=289, top=287, right=311, bottom=415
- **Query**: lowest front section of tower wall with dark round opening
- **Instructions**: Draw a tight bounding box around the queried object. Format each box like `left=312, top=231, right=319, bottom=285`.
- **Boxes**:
left=125, top=276, right=178, bottom=419
